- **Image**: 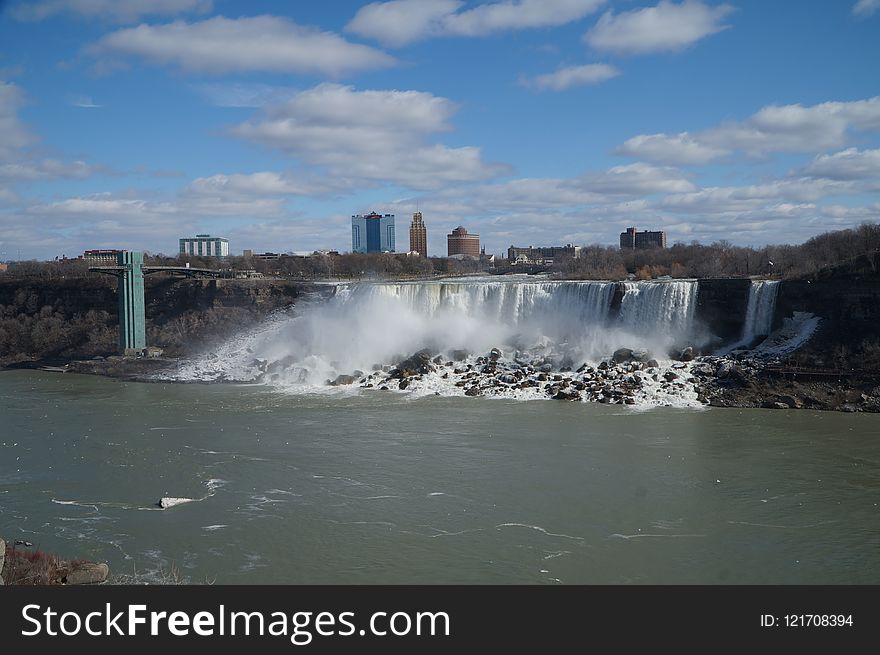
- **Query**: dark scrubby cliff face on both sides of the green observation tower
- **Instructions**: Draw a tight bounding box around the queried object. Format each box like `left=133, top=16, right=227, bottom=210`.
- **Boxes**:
left=0, top=276, right=305, bottom=365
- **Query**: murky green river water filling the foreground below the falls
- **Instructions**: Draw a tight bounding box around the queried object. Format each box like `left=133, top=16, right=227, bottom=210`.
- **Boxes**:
left=0, top=371, right=880, bottom=584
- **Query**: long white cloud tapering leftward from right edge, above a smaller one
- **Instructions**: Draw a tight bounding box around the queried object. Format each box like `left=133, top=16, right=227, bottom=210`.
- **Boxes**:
left=615, top=96, right=880, bottom=164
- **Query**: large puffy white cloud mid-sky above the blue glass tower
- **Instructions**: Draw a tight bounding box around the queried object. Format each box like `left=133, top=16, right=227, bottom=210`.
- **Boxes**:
left=232, top=84, right=507, bottom=189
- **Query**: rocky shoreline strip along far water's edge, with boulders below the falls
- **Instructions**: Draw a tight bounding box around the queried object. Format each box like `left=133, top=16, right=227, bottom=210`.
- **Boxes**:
left=0, top=349, right=880, bottom=413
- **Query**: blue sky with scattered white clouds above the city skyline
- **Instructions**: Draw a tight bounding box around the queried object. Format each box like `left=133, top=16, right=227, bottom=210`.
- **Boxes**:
left=0, top=0, right=880, bottom=261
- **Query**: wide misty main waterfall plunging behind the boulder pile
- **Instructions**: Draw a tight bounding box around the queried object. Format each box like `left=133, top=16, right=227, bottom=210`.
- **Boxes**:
left=178, top=278, right=697, bottom=388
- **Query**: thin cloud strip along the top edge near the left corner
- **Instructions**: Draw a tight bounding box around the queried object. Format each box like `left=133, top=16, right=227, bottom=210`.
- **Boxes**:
left=11, top=0, right=213, bottom=23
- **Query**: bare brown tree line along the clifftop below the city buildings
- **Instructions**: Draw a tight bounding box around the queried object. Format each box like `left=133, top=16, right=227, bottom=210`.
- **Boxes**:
left=6, top=223, right=880, bottom=286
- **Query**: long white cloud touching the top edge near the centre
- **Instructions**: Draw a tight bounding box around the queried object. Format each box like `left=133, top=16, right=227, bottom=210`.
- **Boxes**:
left=346, top=0, right=605, bottom=46
